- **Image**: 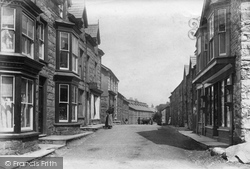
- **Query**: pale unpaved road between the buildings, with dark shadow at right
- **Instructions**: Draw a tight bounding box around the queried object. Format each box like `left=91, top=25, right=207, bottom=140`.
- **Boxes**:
left=49, top=125, right=249, bottom=169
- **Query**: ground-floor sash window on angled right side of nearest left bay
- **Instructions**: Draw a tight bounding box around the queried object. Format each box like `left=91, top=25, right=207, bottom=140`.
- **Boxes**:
left=21, top=78, right=34, bottom=130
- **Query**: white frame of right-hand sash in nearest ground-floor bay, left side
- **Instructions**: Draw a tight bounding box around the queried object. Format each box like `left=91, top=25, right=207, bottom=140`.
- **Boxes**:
left=21, top=77, right=34, bottom=131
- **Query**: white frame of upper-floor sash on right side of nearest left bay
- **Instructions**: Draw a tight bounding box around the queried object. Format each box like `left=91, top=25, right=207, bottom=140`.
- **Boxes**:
left=21, top=13, right=35, bottom=59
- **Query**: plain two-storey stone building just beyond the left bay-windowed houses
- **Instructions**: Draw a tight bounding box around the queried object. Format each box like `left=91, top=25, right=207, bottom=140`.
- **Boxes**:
left=101, top=65, right=119, bottom=123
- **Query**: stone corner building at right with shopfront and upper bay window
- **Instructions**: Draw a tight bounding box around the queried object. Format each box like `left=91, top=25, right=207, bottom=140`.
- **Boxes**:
left=170, top=0, right=250, bottom=144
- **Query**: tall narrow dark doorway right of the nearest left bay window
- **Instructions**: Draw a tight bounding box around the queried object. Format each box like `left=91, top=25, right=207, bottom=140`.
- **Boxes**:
left=38, top=76, right=46, bottom=134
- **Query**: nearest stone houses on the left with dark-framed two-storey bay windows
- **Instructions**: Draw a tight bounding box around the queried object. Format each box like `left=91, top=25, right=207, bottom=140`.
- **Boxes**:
left=0, top=0, right=104, bottom=154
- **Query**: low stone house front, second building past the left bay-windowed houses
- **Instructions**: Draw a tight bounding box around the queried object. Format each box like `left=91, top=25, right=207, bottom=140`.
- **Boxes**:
left=117, top=92, right=129, bottom=124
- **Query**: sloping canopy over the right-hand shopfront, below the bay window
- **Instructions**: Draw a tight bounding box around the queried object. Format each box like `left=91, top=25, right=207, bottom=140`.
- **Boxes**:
left=192, top=56, right=235, bottom=84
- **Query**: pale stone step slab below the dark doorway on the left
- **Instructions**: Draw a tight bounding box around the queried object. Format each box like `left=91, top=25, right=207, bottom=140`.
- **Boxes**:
left=39, top=131, right=93, bottom=145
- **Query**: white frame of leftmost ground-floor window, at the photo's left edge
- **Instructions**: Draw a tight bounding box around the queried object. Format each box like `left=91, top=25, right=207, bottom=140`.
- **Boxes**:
left=0, top=75, right=15, bottom=132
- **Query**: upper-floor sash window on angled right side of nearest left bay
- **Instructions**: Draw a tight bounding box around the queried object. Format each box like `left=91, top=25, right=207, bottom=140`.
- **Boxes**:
left=22, top=14, right=35, bottom=59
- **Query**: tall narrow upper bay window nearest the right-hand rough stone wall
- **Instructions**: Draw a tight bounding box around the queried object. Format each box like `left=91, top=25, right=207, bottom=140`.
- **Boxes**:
left=218, top=9, right=226, bottom=55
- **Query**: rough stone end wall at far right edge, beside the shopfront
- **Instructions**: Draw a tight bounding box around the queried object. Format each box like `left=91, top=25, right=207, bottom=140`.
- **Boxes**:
left=231, top=0, right=250, bottom=143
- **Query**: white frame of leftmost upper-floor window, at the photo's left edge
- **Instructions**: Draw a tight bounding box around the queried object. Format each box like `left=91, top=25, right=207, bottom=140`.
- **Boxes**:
left=0, top=7, right=16, bottom=52
